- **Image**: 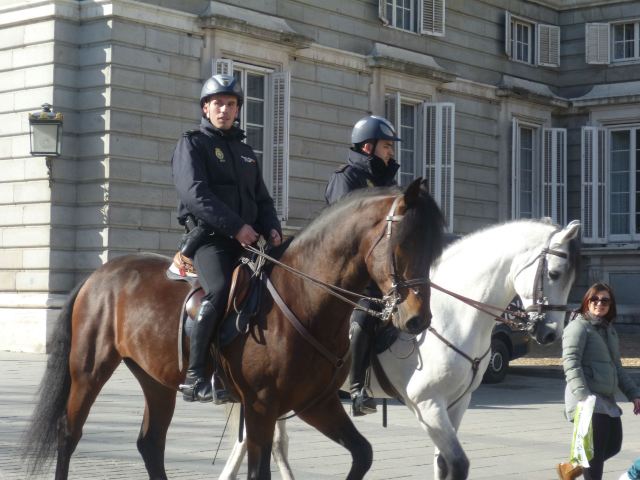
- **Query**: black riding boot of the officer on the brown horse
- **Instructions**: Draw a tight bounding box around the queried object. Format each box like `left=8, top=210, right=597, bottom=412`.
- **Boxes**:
left=180, top=300, right=218, bottom=403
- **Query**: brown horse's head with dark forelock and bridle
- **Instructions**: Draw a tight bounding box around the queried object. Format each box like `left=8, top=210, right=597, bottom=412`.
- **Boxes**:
left=367, top=179, right=444, bottom=334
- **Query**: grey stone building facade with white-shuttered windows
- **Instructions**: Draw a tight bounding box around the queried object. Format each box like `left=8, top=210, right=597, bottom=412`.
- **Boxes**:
left=0, top=0, right=640, bottom=351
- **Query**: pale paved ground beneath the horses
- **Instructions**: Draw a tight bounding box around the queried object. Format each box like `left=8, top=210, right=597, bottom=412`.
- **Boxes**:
left=0, top=352, right=640, bottom=480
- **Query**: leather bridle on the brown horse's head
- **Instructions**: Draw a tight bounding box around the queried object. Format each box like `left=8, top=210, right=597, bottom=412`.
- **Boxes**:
left=365, top=195, right=429, bottom=323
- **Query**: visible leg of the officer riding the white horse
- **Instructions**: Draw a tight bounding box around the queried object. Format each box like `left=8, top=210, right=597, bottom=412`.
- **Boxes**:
left=349, top=310, right=376, bottom=417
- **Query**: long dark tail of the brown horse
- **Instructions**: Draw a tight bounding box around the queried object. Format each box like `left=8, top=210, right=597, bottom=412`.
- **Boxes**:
left=22, top=282, right=84, bottom=477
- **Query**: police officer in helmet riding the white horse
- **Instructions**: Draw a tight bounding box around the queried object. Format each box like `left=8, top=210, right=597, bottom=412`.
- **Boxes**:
left=325, top=115, right=400, bottom=416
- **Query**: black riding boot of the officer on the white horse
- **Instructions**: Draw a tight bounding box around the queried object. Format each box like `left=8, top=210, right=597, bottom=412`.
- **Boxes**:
left=349, top=322, right=376, bottom=417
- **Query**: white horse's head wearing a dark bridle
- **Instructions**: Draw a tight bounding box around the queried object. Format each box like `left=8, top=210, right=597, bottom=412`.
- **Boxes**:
left=512, top=220, right=580, bottom=344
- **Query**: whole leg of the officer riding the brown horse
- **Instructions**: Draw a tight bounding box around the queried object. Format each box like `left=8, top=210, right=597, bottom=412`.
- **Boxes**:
left=182, top=237, right=240, bottom=403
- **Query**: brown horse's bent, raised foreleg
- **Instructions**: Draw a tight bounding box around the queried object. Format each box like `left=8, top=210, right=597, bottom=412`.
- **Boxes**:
left=299, top=394, right=373, bottom=480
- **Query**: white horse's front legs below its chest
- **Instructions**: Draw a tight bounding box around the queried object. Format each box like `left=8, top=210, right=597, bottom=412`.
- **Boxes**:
left=409, top=397, right=469, bottom=480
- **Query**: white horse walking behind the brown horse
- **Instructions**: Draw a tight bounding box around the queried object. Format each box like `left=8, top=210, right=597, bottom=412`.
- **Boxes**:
left=219, top=220, right=580, bottom=480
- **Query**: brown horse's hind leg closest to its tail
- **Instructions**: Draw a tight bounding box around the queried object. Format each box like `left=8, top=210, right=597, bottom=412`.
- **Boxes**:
left=55, top=353, right=120, bottom=480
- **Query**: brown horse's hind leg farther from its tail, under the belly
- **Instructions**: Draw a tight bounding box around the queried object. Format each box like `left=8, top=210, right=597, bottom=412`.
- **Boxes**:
left=124, top=359, right=176, bottom=480
